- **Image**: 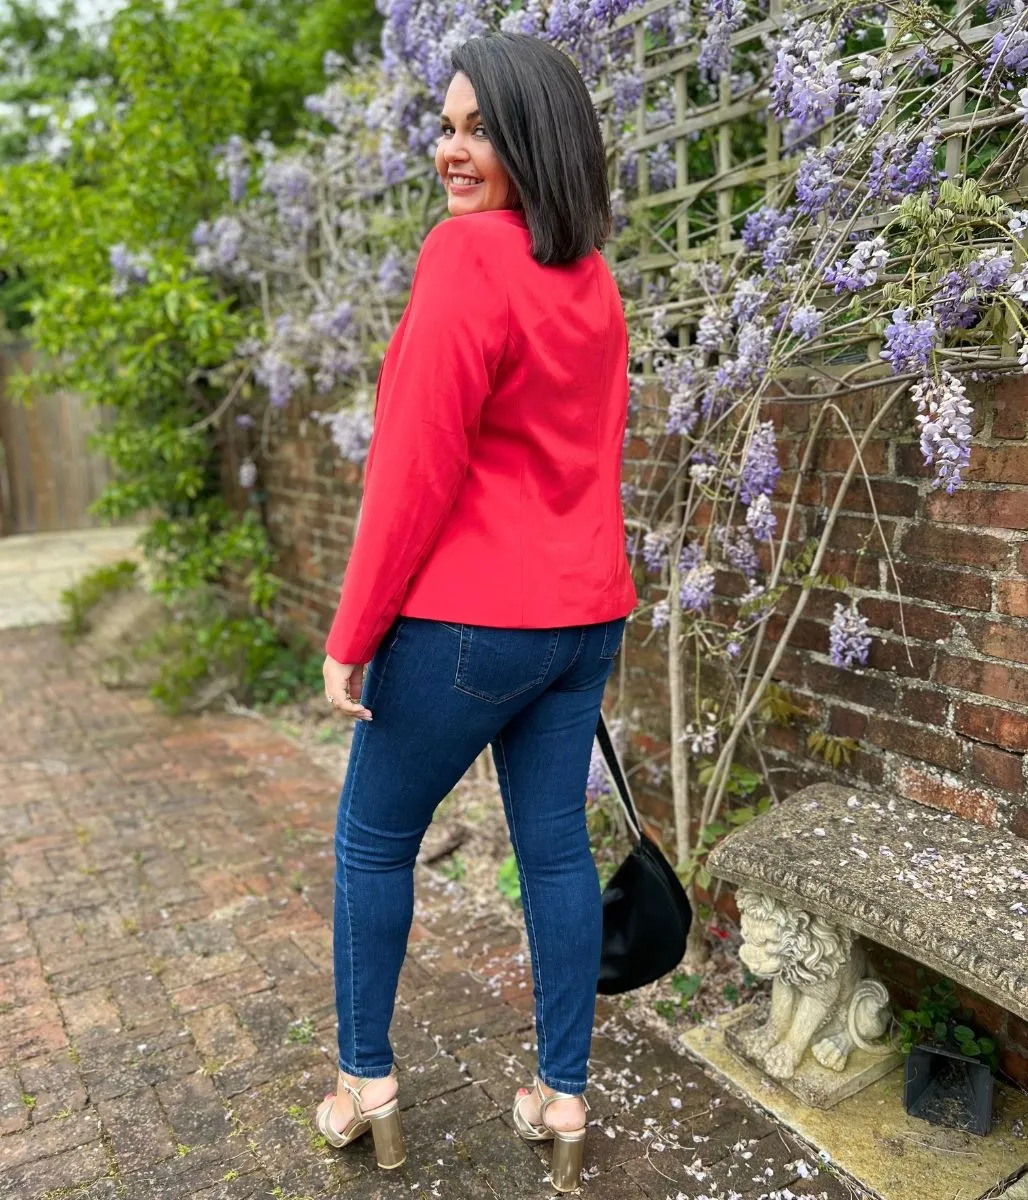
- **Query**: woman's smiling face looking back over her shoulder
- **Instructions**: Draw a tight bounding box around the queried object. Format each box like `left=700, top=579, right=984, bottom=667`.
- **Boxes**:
left=435, top=71, right=513, bottom=217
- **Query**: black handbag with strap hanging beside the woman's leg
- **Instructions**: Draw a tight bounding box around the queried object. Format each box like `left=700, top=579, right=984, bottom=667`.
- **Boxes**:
left=596, top=713, right=692, bottom=996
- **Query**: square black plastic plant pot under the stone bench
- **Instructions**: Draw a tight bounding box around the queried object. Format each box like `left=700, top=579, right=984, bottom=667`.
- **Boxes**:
left=903, top=1045, right=992, bottom=1136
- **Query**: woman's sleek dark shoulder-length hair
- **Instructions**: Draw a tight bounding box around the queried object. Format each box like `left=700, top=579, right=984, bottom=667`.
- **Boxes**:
left=452, top=34, right=611, bottom=266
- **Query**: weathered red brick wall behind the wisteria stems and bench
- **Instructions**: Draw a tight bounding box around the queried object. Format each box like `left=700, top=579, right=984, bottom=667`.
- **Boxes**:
left=226, top=377, right=1028, bottom=1086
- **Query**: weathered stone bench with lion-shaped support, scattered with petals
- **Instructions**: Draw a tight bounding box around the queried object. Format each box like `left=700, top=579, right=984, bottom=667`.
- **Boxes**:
left=708, top=784, right=1028, bottom=1108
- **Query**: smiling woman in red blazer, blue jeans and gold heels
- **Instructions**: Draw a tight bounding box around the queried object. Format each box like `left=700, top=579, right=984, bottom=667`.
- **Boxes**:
left=318, top=35, right=637, bottom=1190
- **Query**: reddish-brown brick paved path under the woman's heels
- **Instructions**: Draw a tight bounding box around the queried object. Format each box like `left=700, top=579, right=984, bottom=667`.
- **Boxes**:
left=0, top=628, right=856, bottom=1200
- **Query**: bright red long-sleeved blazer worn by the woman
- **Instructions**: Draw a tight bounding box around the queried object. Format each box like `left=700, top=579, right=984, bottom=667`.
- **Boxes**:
left=325, top=209, right=637, bottom=664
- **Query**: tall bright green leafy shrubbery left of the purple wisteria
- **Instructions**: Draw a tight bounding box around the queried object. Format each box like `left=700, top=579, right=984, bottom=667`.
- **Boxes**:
left=0, top=0, right=379, bottom=708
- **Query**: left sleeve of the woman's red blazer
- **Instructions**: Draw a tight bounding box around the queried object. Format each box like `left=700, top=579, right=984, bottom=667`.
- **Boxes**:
left=325, top=225, right=507, bottom=664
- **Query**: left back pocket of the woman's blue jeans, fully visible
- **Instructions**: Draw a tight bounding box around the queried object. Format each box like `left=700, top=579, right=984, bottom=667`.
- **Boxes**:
left=453, top=625, right=560, bottom=704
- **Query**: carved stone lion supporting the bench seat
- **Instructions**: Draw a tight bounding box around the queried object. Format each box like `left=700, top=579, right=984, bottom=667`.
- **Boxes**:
left=735, top=887, right=891, bottom=1079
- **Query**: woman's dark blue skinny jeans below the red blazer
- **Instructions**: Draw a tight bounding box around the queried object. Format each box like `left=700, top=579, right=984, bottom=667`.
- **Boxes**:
left=333, top=617, right=625, bottom=1093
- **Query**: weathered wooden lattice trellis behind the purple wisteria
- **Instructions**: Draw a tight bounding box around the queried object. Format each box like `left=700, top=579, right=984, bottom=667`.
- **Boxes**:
left=594, top=0, right=1028, bottom=366
